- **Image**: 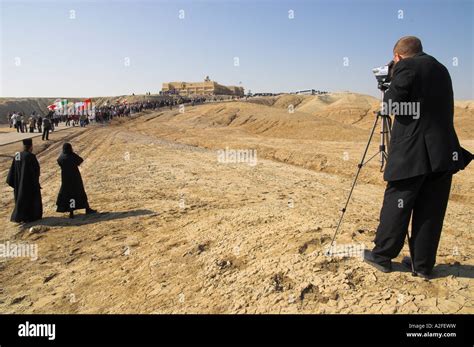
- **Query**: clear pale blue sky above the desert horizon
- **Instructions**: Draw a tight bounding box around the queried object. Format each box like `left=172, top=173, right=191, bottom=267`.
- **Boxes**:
left=0, top=0, right=474, bottom=99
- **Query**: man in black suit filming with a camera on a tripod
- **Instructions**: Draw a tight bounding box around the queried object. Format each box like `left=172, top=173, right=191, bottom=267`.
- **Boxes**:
left=364, top=36, right=472, bottom=278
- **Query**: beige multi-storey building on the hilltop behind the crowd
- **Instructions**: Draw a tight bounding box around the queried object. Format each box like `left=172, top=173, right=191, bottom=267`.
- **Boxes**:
left=161, top=77, right=244, bottom=96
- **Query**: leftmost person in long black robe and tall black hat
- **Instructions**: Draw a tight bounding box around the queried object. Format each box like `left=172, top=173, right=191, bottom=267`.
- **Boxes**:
left=7, top=139, right=43, bottom=223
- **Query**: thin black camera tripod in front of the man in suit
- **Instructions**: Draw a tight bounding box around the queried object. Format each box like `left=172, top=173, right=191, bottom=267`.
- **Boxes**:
left=326, top=90, right=415, bottom=275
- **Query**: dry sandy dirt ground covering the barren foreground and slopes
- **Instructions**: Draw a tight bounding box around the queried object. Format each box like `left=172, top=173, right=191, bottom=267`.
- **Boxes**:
left=0, top=94, right=474, bottom=313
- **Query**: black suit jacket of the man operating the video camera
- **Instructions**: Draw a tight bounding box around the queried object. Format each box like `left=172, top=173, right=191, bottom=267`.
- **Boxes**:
left=384, top=52, right=472, bottom=181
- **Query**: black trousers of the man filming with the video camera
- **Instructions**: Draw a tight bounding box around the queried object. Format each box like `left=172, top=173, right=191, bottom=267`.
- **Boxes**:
left=373, top=172, right=453, bottom=273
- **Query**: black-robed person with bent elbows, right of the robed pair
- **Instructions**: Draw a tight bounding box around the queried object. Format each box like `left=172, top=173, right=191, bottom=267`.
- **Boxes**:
left=56, top=143, right=97, bottom=218
